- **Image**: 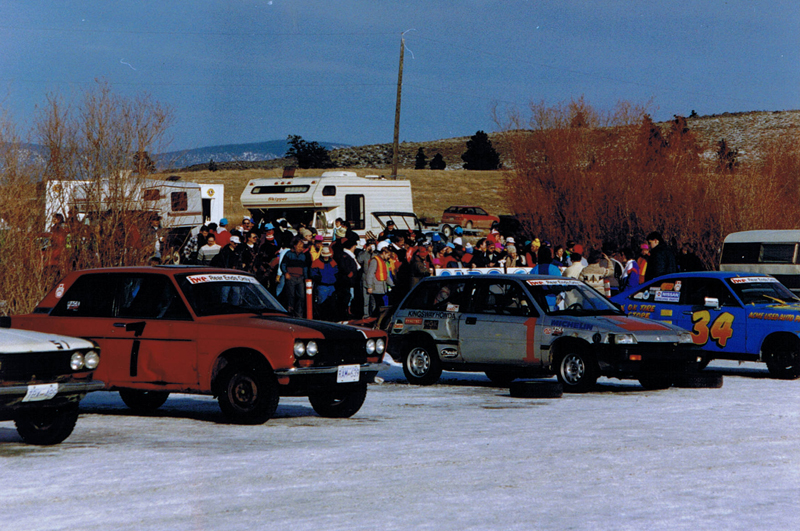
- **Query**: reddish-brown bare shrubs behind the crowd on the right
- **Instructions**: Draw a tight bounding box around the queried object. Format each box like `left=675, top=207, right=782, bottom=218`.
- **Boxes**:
left=506, top=99, right=800, bottom=267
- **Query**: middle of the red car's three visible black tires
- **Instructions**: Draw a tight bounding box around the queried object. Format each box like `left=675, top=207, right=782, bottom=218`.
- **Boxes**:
left=216, top=365, right=280, bottom=424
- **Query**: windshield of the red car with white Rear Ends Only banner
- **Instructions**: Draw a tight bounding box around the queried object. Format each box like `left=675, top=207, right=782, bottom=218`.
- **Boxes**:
left=178, top=273, right=287, bottom=316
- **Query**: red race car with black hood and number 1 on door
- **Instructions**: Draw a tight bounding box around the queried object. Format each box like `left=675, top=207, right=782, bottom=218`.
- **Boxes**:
left=11, top=266, right=386, bottom=424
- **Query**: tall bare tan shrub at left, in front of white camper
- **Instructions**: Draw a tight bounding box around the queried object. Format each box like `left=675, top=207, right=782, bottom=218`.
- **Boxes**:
left=0, top=83, right=172, bottom=313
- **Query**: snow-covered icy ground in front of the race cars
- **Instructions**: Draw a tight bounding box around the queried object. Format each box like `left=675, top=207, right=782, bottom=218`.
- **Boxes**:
left=0, top=362, right=800, bottom=531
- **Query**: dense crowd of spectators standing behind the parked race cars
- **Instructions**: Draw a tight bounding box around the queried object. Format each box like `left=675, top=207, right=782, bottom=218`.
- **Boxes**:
left=182, top=217, right=702, bottom=321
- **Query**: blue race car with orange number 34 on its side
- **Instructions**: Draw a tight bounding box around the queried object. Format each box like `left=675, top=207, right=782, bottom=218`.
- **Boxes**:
left=611, top=272, right=800, bottom=379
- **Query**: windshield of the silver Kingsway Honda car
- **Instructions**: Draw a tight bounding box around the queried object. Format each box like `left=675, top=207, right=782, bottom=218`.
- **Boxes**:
left=525, top=279, right=623, bottom=315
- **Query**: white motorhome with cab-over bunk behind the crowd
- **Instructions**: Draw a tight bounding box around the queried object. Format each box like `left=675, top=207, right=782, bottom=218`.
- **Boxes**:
left=242, top=171, right=414, bottom=236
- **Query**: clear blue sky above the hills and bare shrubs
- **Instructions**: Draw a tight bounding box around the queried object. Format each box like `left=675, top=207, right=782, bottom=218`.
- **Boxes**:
left=0, top=0, right=800, bottom=150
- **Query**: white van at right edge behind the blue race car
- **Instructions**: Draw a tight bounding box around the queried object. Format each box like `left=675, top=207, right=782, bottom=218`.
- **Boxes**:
left=719, top=230, right=800, bottom=292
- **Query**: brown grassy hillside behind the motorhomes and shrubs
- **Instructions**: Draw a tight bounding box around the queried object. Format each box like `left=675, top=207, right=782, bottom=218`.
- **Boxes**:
left=164, top=111, right=800, bottom=224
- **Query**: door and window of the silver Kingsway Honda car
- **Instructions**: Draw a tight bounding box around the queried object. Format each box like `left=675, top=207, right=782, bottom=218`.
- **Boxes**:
left=458, top=277, right=541, bottom=365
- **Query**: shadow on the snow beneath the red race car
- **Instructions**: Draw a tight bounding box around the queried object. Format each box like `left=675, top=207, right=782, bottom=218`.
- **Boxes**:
left=76, top=392, right=334, bottom=426
